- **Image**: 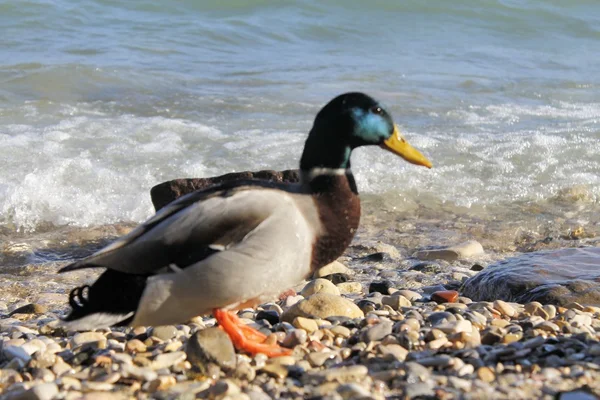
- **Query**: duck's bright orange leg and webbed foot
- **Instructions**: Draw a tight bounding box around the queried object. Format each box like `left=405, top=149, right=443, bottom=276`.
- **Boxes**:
left=213, top=309, right=292, bottom=357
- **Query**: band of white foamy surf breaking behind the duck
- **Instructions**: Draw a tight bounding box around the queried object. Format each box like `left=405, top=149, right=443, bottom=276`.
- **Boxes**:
left=0, top=102, right=600, bottom=230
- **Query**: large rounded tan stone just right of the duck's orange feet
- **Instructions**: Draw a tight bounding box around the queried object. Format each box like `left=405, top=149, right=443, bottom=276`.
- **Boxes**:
left=281, top=293, right=364, bottom=322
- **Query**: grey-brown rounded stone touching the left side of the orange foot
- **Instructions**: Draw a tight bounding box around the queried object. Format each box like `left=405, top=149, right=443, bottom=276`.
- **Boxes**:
left=185, top=328, right=237, bottom=372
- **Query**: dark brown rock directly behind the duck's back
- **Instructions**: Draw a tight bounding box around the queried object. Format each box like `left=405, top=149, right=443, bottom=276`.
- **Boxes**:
left=150, top=169, right=300, bottom=211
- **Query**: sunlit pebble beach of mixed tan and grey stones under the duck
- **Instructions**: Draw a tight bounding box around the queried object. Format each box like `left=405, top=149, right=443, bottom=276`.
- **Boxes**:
left=0, top=214, right=600, bottom=400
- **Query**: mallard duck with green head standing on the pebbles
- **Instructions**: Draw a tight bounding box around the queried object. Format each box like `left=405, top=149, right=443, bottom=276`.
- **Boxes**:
left=60, top=93, right=431, bottom=356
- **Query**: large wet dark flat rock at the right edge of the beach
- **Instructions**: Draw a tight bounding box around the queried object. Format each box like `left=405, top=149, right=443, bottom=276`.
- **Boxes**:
left=462, top=247, right=600, bottom=306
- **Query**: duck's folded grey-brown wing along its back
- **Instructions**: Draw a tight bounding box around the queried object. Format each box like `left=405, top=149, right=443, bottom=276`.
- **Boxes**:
left=60, top=184, right=298, bottom=274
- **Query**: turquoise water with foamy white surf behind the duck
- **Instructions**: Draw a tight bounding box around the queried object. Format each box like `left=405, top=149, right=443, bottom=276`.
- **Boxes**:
left=0, top=0, right=600, bottom=234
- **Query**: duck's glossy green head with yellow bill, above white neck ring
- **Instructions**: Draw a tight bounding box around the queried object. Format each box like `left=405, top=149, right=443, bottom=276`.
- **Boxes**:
left=300, top=93, right=431, bottom=170
